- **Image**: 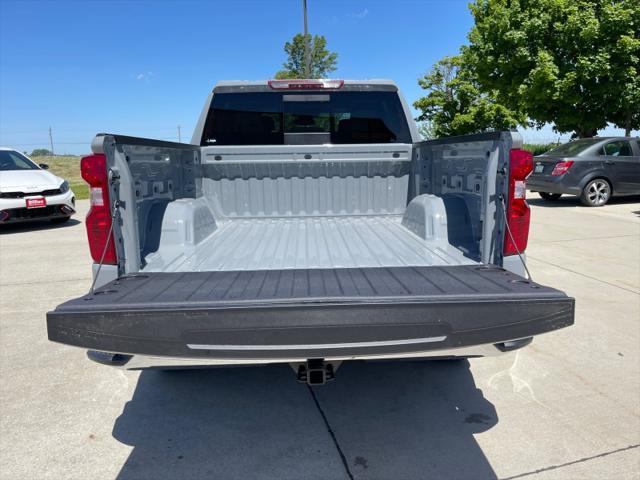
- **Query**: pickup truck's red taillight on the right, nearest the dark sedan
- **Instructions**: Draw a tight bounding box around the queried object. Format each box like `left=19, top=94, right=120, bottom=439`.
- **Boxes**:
left=504, top=148, right=533, bottom=256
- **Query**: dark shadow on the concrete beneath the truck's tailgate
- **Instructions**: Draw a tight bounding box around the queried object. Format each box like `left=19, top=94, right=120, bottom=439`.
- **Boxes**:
left=113, top=361, right=498, bottom=480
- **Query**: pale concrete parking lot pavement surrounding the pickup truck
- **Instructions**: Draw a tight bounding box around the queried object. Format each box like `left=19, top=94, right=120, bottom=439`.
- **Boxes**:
left=0, top=196, right=640, bottom=479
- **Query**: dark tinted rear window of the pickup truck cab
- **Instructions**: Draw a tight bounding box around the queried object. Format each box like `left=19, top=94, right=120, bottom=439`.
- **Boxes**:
left=201, top=92, right=411, bottom=145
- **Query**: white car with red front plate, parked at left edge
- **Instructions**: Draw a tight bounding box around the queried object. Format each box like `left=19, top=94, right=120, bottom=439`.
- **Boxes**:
left=0, top=147, right=76, bottom=225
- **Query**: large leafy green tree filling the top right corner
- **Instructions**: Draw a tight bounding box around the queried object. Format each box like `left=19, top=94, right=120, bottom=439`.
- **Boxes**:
left=462, top=0, right=640, bottom=137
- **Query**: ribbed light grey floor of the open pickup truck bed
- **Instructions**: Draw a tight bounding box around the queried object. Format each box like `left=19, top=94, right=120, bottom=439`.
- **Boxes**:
left=144, top=215, right=477, bottom=272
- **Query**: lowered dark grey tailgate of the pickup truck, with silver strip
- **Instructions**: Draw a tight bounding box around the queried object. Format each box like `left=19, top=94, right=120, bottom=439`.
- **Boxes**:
left=47, top=265, right=574, bottom=358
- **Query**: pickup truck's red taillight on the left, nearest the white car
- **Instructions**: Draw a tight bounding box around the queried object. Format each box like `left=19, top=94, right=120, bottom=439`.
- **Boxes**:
left=80, top=154, right=118, bottom=265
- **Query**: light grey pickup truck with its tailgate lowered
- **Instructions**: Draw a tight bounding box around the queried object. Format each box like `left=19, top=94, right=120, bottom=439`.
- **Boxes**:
left=47, top=80, right=574, bottom=384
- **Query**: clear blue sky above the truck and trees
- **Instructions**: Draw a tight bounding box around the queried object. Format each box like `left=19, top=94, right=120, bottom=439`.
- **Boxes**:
left=0, top=0, right=632, bottom=153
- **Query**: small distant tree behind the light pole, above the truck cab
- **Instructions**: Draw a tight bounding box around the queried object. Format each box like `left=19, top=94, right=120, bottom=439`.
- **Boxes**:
left=276, top=33, right=338, bottom=79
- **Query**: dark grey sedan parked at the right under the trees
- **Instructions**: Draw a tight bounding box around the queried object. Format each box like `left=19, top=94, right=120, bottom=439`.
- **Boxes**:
left=527, top=137, right=640, bottom=207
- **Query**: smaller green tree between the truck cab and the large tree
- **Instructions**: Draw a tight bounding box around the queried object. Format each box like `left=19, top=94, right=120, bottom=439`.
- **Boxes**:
left=413, top=55, right=526, bottom=138
